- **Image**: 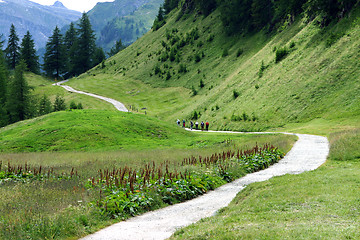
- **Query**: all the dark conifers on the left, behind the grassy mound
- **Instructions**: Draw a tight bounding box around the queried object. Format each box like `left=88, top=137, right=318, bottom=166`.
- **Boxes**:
left=0, top=18, right=100, bottom=127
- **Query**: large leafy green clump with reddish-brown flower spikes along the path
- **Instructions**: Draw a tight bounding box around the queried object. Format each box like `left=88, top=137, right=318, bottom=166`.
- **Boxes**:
left=86, top=145, right=284, bottom=219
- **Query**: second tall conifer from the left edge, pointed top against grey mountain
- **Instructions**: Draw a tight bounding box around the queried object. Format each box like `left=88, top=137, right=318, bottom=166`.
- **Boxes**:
left=20, top=31, right=40, bottom=74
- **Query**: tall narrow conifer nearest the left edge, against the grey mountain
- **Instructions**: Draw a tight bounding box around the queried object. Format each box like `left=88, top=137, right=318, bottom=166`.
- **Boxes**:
left=5, top=24, right=20, bottom=69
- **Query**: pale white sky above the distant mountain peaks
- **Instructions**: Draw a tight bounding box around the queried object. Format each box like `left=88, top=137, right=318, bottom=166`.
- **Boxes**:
left=30, top=0, right=114, bottom=12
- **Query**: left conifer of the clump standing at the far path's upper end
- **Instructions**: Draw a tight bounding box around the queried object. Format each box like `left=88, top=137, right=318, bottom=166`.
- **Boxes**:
left=43, top=26, right=66, bottom=79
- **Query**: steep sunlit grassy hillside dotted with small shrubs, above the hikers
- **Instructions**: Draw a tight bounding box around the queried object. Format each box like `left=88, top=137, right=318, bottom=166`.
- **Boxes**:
left=70, top=7, right=360, bottom=130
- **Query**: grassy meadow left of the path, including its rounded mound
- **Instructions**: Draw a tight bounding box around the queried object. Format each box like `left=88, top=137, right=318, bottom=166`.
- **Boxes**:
left=0, top=113, right=296, bottom=239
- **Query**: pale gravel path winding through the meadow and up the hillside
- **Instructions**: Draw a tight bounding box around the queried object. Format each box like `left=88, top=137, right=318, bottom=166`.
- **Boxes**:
left=53, top=81, right=329, bottom=240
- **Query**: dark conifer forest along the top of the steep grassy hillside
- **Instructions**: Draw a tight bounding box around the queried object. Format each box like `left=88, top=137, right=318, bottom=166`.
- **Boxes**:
left=159, top=0, right=359, bottom=34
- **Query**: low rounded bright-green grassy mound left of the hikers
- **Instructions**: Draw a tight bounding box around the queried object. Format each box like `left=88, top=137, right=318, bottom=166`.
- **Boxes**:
left=0, top=110, right=197, bottom=152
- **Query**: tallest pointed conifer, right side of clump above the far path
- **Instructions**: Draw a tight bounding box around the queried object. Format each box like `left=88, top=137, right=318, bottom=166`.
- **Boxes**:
left=74, top=13, right=96, bottom=75
